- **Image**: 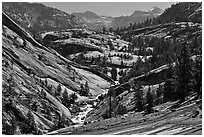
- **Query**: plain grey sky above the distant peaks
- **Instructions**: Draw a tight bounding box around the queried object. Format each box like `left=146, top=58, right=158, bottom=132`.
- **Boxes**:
left=41, top=2, right=175, bottom=17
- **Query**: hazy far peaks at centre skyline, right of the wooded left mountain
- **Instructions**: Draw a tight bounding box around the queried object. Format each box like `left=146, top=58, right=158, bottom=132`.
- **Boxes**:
left=72, top=7, right=163, bottom=29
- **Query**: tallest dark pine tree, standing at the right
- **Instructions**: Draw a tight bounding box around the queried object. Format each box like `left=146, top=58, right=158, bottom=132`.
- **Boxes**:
left=177, top=42, right=192, bottom=102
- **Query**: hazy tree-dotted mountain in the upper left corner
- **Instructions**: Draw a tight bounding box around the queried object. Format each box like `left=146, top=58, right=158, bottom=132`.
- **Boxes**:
left=2, top=2, right=83, bottom=33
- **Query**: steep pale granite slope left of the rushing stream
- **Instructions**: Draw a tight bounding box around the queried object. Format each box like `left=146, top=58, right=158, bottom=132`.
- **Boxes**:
left=2, top=13, right=109, bottom=134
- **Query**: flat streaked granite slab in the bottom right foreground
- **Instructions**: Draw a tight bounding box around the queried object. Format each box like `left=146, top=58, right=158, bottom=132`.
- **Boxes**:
left=48, top=98, right=202, bottom=135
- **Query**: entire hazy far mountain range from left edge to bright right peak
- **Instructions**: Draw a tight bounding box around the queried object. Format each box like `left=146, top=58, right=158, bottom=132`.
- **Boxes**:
left=2, top=2, right=163, bottom=33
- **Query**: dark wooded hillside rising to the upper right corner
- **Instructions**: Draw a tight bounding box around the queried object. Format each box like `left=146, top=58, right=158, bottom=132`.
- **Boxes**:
left=117, top=2, right=202, bottom=34
